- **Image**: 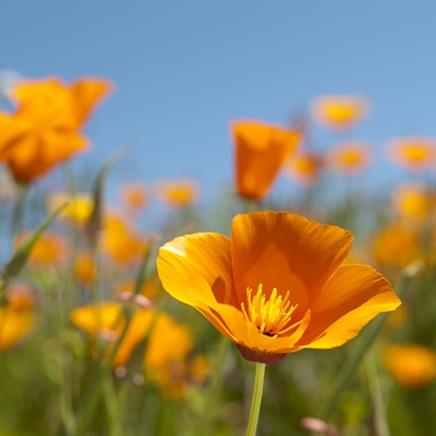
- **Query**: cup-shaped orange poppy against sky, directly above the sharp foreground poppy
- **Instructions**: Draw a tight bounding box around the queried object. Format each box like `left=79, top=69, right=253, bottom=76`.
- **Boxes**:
left=231, top=121, right=301, bottom=200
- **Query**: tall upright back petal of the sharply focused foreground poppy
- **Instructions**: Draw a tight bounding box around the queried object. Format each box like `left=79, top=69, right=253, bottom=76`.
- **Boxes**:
left=232, top=212, right=352, bottom=310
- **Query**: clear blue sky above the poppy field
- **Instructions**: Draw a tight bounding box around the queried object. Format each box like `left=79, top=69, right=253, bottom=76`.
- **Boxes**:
left=0, top=0, right=436, bottom=196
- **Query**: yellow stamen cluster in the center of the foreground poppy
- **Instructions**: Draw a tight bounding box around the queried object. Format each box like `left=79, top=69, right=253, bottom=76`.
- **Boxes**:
left=241, top=283, right=299, bottom=337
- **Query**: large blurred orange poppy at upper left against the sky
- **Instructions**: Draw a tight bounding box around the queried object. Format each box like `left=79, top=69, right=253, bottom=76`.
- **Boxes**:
left=0, top=78, right=110, bottom=183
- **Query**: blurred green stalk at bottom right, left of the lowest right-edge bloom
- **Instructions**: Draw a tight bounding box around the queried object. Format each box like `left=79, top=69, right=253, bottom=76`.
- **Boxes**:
left=365, top=350, right=390, bottom=436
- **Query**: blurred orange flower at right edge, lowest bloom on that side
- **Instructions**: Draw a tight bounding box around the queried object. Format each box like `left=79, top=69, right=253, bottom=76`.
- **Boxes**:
left=384, top=345, right=436, bottom=388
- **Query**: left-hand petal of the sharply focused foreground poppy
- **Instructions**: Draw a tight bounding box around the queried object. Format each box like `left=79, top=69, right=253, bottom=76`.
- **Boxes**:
left=157, top=233, right=234, bottom=308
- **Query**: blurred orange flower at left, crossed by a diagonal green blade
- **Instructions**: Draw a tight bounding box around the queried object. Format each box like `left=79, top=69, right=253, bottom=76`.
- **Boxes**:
left=14, top=232, right=68, bottom=266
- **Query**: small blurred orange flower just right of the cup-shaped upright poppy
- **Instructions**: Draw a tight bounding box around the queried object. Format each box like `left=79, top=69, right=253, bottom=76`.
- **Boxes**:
left=285, top=151, right=324, bottom=184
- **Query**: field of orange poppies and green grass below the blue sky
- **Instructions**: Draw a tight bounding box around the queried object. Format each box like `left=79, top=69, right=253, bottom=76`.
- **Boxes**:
left=0, top=77, right=436, bottom=436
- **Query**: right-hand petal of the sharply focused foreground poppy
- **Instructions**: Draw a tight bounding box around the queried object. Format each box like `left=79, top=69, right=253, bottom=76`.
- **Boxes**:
left=299, top=265, right=401, bottom=348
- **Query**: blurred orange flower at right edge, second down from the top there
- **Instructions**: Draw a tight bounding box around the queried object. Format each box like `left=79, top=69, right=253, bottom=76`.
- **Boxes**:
left=393, top=183, right=436, bottom=220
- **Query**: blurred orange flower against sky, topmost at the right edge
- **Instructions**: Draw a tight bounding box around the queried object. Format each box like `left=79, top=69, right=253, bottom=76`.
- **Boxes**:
left=389, top=137, right=436, bottom=170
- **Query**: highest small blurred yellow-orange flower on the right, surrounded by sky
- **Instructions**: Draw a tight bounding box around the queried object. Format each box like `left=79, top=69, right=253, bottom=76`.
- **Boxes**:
left=312, top=96, right=368, bottom=130
